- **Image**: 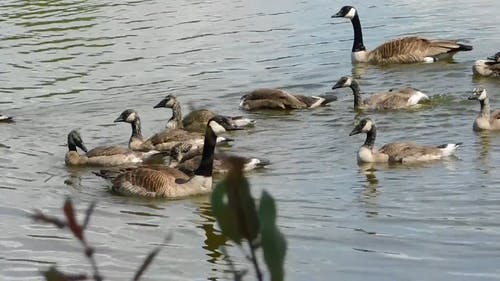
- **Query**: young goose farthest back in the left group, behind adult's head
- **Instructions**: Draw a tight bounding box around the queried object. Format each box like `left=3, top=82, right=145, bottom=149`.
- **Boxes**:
left=153, top=95, right=255, bottom=133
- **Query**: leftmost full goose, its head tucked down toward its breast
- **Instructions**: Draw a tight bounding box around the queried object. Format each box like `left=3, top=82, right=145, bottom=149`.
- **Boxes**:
left=64, top=130, right=163, bottom=166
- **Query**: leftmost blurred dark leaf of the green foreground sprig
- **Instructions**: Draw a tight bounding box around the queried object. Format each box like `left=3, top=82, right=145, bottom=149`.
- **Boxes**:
left=211, top=180, right=241, bottom=244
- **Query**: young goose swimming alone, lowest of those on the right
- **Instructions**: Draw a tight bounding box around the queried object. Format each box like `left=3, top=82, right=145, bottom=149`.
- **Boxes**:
left=349, top=118, right=462, bottom=163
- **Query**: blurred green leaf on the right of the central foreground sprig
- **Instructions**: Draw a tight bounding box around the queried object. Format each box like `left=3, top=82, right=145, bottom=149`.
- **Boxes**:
left=259, top=191, right=287, bottom=281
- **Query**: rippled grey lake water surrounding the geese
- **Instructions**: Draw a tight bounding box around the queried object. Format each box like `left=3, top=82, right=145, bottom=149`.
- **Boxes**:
left=0, top=0, right=500, bottom=281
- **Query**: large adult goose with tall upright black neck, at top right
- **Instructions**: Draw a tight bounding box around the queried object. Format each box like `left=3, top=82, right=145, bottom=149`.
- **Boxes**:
left=332, top=6, right=472, bottom=64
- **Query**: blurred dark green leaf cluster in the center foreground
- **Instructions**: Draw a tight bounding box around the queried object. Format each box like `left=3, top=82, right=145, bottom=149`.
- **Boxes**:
left=211, top=157, right=287, bottom=281
